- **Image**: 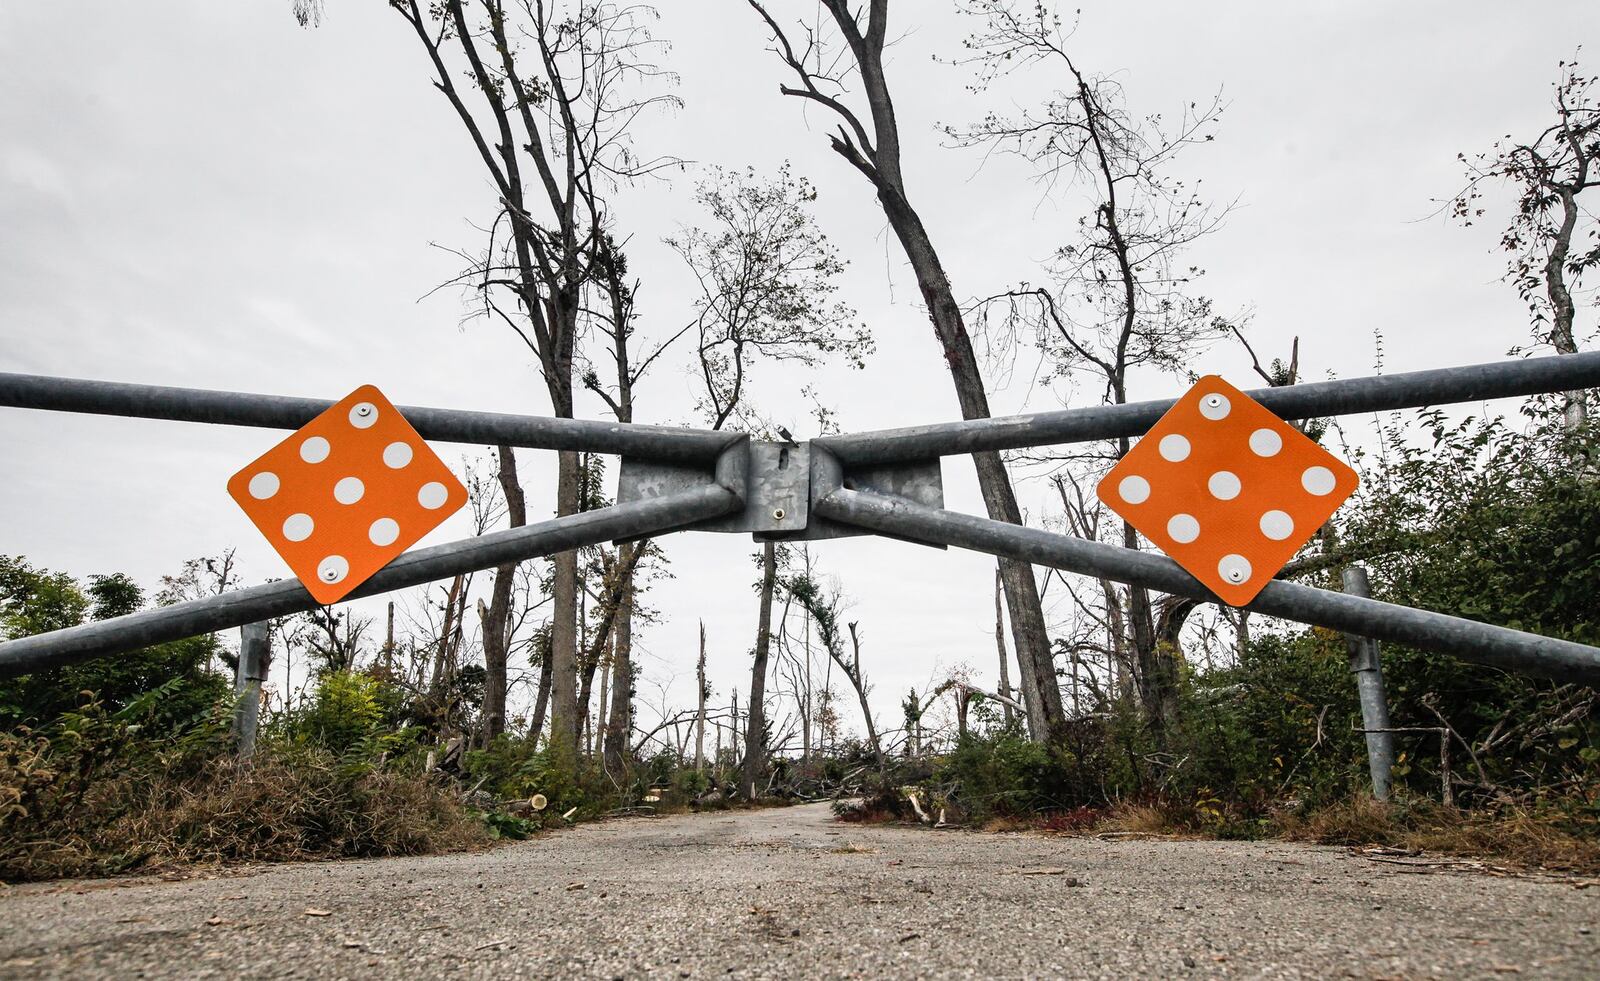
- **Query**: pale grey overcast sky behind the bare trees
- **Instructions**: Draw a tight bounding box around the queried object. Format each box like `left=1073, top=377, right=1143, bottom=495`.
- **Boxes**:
left=0, top=0, right=1600, bottom=736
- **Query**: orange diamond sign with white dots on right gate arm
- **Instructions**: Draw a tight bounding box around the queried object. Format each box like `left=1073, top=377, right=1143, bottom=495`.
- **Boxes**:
left=1096, top=374, right=1358, bottom=607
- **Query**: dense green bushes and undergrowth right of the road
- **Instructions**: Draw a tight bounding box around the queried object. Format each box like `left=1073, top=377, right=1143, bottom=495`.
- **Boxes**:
left=848, top=405, right=1600, bottom=872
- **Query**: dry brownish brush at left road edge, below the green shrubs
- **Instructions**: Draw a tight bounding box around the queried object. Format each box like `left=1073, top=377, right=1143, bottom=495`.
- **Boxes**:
left=0, top=691, right=486, bottom=880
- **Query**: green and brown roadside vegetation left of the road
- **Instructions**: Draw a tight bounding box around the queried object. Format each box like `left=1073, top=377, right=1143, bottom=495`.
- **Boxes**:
left=0, top=555, right=761, bottom=882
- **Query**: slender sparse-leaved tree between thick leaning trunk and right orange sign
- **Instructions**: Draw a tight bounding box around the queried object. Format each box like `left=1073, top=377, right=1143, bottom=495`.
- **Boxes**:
left=947, top=0, right=1230, bottom=730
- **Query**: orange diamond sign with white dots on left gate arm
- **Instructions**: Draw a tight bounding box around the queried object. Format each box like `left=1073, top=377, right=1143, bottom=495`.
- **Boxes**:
left=227, top=386, right=467, bottom=605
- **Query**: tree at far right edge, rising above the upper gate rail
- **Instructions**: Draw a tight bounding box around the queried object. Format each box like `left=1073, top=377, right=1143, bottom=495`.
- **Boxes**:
left=1448, top=61, right=1600, bottom=432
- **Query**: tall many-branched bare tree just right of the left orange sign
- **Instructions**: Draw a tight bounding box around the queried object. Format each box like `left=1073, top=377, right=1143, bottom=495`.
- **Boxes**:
left=392, top=0, right=674, bottom=770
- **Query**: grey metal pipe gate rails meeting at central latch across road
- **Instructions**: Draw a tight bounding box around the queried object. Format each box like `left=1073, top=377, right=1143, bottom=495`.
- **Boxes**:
left=0, top=352, right=1600, bottom=685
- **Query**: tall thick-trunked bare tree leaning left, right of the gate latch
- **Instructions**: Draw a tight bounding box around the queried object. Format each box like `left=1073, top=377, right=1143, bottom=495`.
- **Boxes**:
left=747, top=0, right=1064, bottom=739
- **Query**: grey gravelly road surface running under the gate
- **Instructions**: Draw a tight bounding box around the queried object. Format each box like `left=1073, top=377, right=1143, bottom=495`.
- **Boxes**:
left=0, top=805, right=1600, bottom=978
